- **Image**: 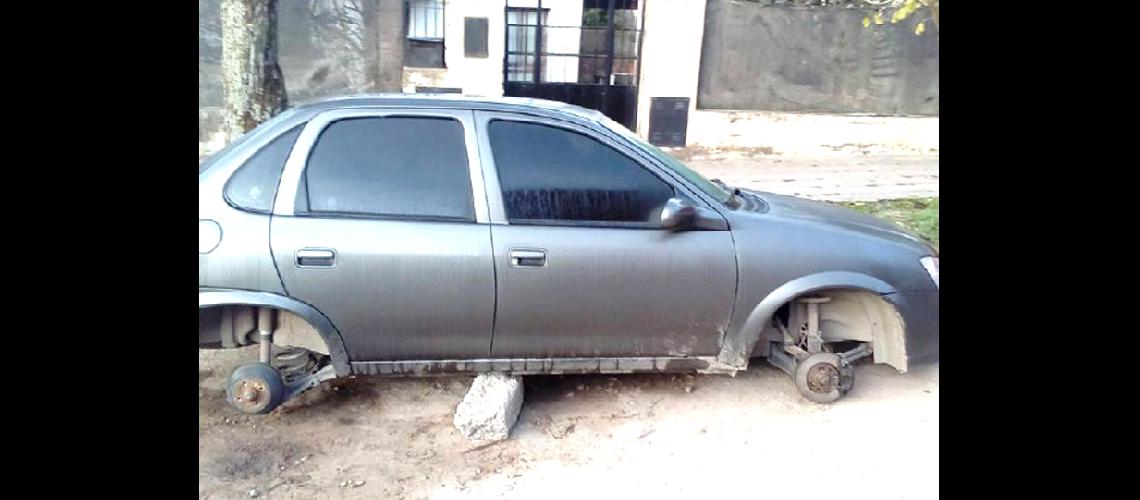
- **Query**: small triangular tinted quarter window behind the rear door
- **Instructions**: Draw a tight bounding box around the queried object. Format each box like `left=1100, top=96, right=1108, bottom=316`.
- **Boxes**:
left=226, top=126, right=301, bottom=213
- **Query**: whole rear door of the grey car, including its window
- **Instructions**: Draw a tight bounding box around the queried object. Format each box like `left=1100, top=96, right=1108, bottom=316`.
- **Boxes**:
left=270, top=109, right=495, bottom=361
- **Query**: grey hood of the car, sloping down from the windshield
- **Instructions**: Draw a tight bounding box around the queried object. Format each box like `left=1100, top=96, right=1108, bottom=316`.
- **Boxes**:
left=736, top=189, right=933, bottom=253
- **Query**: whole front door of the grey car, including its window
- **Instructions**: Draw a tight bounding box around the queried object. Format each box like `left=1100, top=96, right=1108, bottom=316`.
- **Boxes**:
left=477, top=113, right=736, bottom=358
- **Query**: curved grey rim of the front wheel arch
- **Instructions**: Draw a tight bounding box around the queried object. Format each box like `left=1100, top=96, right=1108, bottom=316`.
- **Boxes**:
left=717, top=271, right=898, bottom=370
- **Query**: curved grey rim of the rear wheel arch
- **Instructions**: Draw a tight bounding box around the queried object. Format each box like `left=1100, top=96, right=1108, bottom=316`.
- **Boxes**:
left=198, top=288, right=352, bottom=377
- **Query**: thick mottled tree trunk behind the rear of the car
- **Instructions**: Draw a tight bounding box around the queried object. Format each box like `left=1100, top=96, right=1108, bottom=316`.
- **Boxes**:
left=221, top=0, right=288, bottom=140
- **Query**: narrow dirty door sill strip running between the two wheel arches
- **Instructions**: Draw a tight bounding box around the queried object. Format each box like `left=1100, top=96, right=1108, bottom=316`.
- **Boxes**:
left=352, top=355, right=743, bottom=376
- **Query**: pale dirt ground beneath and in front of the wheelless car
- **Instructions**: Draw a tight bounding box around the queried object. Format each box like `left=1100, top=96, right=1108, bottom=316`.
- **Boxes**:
left=198, top=350, right=938, bottom=499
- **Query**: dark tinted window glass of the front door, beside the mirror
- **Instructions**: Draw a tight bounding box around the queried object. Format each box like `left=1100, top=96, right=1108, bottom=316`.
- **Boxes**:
left=489, top=121, right=675, bottom=223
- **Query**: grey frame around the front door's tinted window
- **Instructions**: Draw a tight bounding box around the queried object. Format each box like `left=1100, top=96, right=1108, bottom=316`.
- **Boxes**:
left=477, top=112, right=693, bottom=230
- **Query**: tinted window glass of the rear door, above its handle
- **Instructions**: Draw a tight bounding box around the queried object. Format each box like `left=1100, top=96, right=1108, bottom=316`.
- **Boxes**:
left=298, top=117, right=474, bottom=220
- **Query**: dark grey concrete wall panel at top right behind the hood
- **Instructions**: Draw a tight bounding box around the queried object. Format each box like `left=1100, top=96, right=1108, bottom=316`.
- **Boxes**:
left=698, top=0, right=938, bottom=115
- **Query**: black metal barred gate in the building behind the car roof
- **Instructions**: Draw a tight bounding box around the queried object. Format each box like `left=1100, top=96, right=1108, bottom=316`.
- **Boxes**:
left=503, top=0, right=644, bottom=130
